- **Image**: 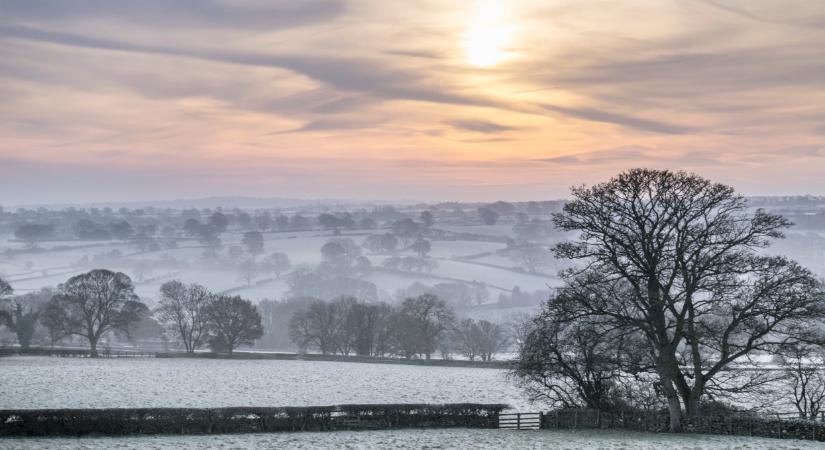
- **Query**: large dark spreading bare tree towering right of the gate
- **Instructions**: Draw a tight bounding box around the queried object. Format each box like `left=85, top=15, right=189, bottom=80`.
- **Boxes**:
left=554, top=169, right=823, bottom=431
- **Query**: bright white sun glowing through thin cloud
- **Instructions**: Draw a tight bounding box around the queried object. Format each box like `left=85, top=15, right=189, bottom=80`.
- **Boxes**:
left=464, top=0, right=510, bottom=67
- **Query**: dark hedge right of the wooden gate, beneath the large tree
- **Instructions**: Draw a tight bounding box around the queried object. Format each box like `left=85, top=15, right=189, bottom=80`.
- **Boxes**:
left=541, top=409, right=825, bottom=441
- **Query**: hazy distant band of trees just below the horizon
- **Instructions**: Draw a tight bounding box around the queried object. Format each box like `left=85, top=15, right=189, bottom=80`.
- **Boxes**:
left=0, top=201, right=560, bottom=250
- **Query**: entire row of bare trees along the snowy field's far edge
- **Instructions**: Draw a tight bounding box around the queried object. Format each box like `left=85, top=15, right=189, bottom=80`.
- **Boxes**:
left=0, top=269, right=510, bottom=361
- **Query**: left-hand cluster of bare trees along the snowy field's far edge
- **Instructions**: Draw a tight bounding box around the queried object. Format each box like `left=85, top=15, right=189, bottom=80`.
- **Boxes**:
left=0, top=269, right=263, bottom=357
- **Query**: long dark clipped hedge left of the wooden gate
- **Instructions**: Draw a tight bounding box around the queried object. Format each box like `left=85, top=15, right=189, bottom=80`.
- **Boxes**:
left=0, top=403, right=507, bottom=436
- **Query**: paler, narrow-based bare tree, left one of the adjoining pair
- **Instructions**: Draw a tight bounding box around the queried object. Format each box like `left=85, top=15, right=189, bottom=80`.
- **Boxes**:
left=156, top=280, right=213, bottom=353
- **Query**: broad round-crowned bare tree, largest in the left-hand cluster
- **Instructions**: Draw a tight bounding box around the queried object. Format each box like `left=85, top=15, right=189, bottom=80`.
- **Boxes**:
left=49, top=269, right=145, bottom=358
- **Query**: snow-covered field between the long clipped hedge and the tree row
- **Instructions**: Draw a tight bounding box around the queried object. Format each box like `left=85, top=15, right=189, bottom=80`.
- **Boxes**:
left=0, top=357, right=537, bottom=410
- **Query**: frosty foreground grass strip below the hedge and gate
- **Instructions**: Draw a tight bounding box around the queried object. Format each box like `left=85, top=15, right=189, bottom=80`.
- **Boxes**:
left=0, top=428, right=823, bottom=450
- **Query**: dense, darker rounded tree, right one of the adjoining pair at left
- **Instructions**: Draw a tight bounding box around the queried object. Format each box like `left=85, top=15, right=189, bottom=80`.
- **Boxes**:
left=206, top=295, right=264, bottom=354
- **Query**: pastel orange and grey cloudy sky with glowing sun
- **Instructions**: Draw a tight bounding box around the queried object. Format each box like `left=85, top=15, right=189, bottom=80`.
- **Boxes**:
left=0, top=0, right=825, bottom=205
